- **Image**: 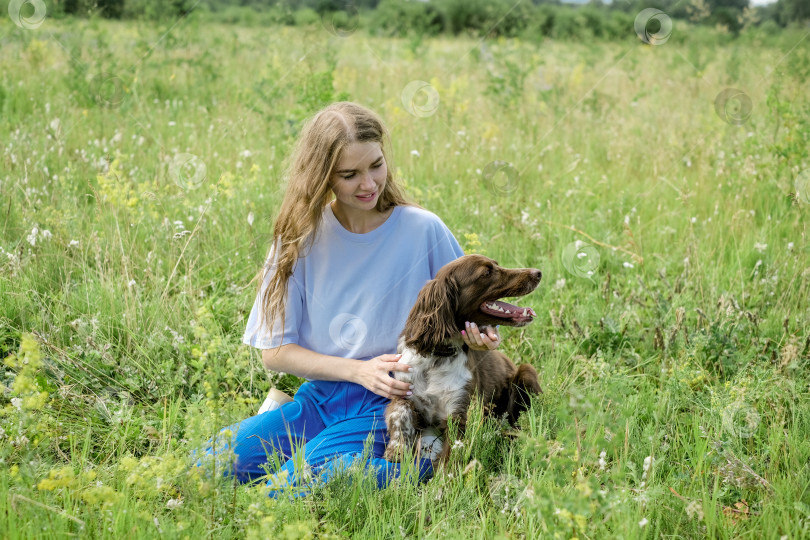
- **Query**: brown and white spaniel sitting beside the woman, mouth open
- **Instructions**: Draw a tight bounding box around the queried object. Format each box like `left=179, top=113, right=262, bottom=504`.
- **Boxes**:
left=384, top=255, right=542, bottom=462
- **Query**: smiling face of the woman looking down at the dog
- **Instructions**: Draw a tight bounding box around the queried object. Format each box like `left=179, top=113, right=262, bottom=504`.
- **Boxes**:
left=331, top=142, right=388, bottom=210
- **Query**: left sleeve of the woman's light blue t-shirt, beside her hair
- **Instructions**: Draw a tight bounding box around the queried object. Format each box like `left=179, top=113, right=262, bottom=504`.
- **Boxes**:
left=242, top=242, right=304, bottom=349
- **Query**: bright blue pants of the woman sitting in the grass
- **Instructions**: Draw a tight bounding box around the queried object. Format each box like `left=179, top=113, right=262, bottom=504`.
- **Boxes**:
left=200, top=381, right=433, bottom=497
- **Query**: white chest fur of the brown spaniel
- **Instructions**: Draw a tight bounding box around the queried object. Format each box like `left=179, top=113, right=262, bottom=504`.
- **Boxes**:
left=394, top=342, right=472, bottom=425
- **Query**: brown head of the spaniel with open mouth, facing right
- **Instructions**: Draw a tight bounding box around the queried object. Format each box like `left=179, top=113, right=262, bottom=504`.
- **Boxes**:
left=404, top=255, right=542, bottom=355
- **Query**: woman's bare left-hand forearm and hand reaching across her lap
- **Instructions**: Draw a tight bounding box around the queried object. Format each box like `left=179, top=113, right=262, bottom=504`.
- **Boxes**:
left=262, top=343, right=411, bottom=398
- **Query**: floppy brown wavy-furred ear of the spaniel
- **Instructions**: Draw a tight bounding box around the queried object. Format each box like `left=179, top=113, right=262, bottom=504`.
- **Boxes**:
left=404, top=276, right=460, bottom=356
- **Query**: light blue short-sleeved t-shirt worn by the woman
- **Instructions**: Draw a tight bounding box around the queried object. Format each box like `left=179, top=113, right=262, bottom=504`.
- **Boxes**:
left=242, top=205, right=464, bottom=360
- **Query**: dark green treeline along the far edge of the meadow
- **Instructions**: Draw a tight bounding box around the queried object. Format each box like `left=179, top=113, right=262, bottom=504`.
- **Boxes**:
left=7, top=0, right=810, bottom=39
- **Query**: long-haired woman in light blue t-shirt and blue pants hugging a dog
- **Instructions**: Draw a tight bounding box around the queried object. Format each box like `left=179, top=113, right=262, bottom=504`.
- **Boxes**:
left=208, top=102, right=500, bottom=493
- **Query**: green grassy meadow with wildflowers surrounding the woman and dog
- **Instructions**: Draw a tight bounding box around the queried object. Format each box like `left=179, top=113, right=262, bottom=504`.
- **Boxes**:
left=0, top=10, right=810, bottom=539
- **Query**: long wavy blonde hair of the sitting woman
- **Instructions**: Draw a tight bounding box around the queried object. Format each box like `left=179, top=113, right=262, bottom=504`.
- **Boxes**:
left=258, top=101, right=412, bottom=340
